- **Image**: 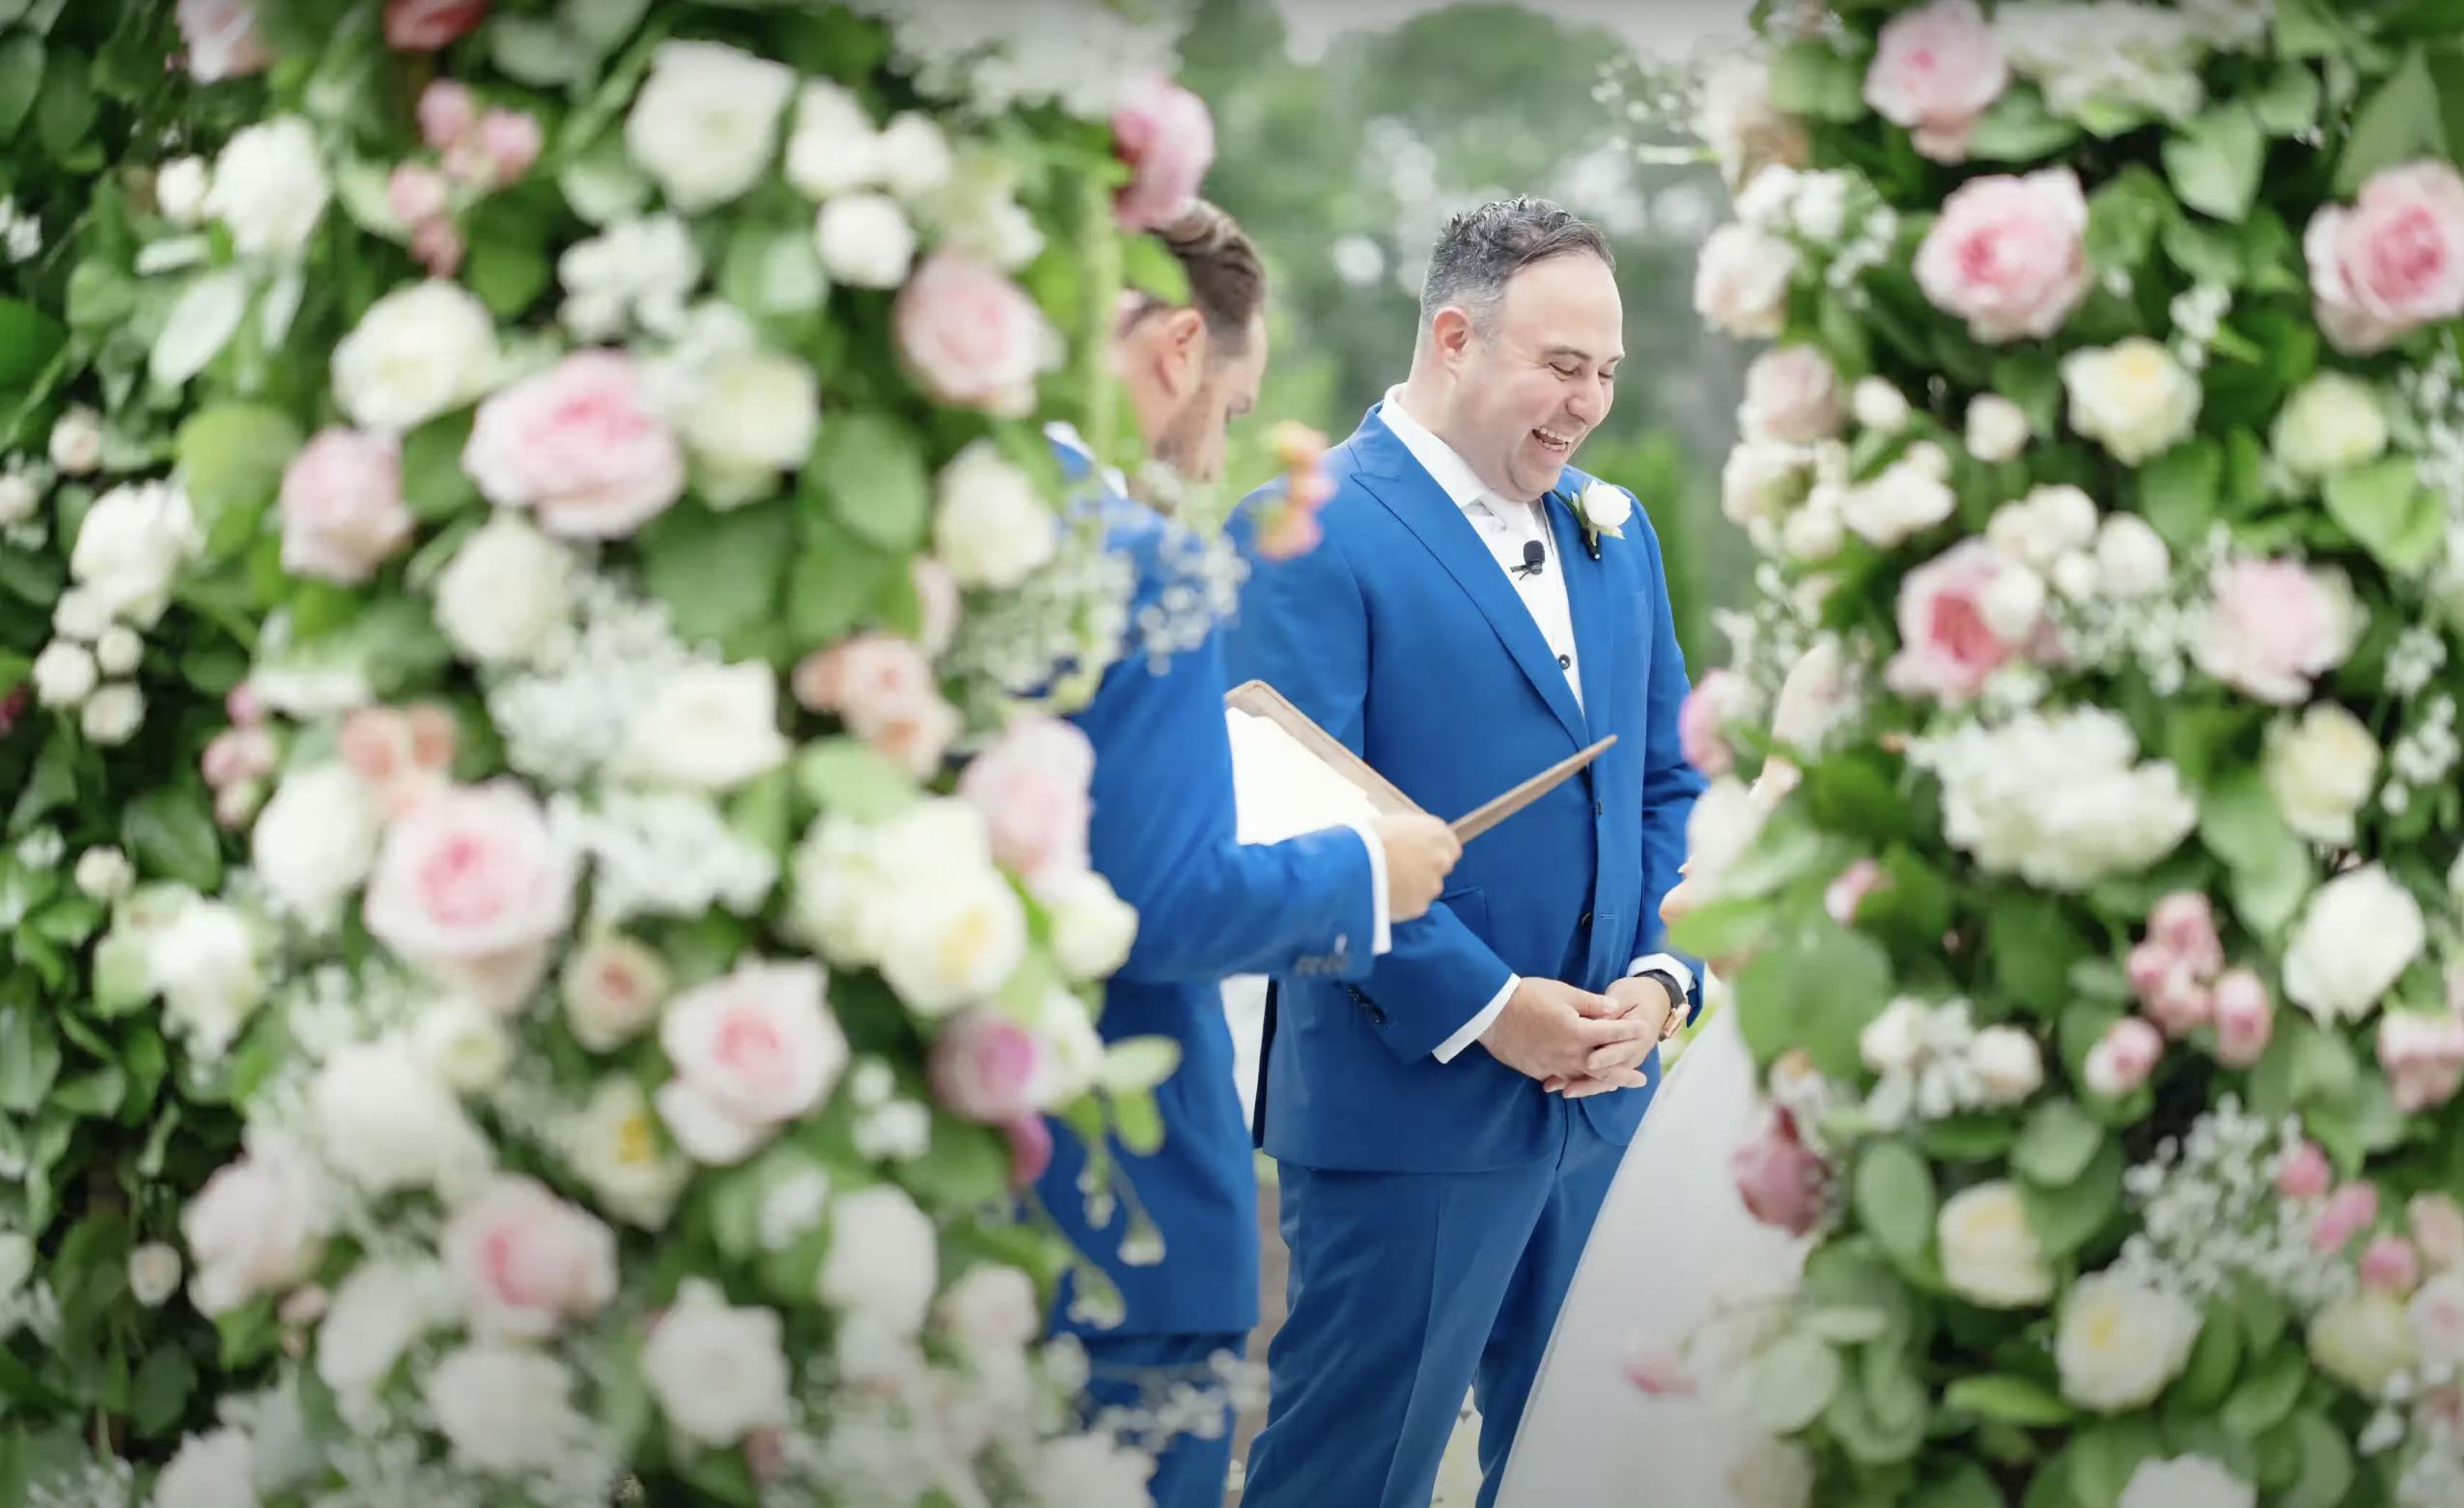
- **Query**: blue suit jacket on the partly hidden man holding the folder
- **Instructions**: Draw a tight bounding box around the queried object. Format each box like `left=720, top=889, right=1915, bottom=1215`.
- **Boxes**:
left=1037, top=446, right=1378, bottom=1335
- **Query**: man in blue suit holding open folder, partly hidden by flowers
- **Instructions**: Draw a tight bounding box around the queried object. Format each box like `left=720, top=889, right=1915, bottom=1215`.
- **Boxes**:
left=1037, top=205, right=1461, bottom=1508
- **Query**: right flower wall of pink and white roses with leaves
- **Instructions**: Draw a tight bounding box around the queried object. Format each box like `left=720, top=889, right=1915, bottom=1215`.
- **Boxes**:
left=1680, top=0, right=2464, bottom=1508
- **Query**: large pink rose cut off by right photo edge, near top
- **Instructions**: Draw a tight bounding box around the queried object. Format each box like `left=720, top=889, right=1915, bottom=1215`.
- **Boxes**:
left=2302, top=160, right=2464, bottom=355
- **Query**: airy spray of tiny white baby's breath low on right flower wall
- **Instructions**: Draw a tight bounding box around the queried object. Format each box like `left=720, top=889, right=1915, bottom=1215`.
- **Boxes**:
left=2114, top=1094, right=2353, bottom=1313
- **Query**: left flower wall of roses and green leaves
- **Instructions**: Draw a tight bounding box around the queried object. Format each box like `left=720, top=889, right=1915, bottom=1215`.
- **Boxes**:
left=0, top=0, right=1219, bottom=1505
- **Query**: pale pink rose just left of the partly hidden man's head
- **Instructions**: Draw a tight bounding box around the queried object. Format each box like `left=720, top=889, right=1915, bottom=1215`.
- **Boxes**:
left=892, top=251, right=1050, bottom=419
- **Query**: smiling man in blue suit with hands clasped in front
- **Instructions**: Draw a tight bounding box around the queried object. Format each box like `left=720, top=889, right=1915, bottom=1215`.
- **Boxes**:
left=1227, top=200, right=1700, bottom=1508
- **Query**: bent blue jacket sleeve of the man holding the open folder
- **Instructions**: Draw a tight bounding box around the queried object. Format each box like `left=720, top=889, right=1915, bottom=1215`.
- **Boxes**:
left=1079, top=613, right=1385, bottom=983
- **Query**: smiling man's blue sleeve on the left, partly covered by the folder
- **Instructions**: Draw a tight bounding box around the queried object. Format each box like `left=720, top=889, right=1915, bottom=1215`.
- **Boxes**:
left=1224, top=495, right=1507, bottom=1062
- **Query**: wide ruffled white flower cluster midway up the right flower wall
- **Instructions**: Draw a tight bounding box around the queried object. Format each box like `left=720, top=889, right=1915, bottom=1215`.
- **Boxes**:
left=1907, top=708, right=2198, bottom=892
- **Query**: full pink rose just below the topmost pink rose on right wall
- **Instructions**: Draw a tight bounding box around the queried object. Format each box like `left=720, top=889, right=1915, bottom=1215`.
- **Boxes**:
left=1917, top=168, right=2087, bottom=345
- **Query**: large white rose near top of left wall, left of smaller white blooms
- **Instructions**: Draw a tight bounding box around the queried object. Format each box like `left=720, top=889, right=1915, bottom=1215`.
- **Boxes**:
left=624, top=42, right=796, bottom=211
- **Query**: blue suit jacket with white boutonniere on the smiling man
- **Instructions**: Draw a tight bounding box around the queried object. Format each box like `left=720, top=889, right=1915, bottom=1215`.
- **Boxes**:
left=1227, top=409, right=1702, bottom=1173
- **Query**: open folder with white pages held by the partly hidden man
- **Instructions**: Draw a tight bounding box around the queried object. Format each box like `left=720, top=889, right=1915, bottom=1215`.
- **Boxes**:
left=1224, top=680, right=1616, bottom=843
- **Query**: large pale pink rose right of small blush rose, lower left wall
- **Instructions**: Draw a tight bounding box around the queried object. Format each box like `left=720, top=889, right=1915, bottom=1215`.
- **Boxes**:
left=658, top=961, right=848, bottom=1165
